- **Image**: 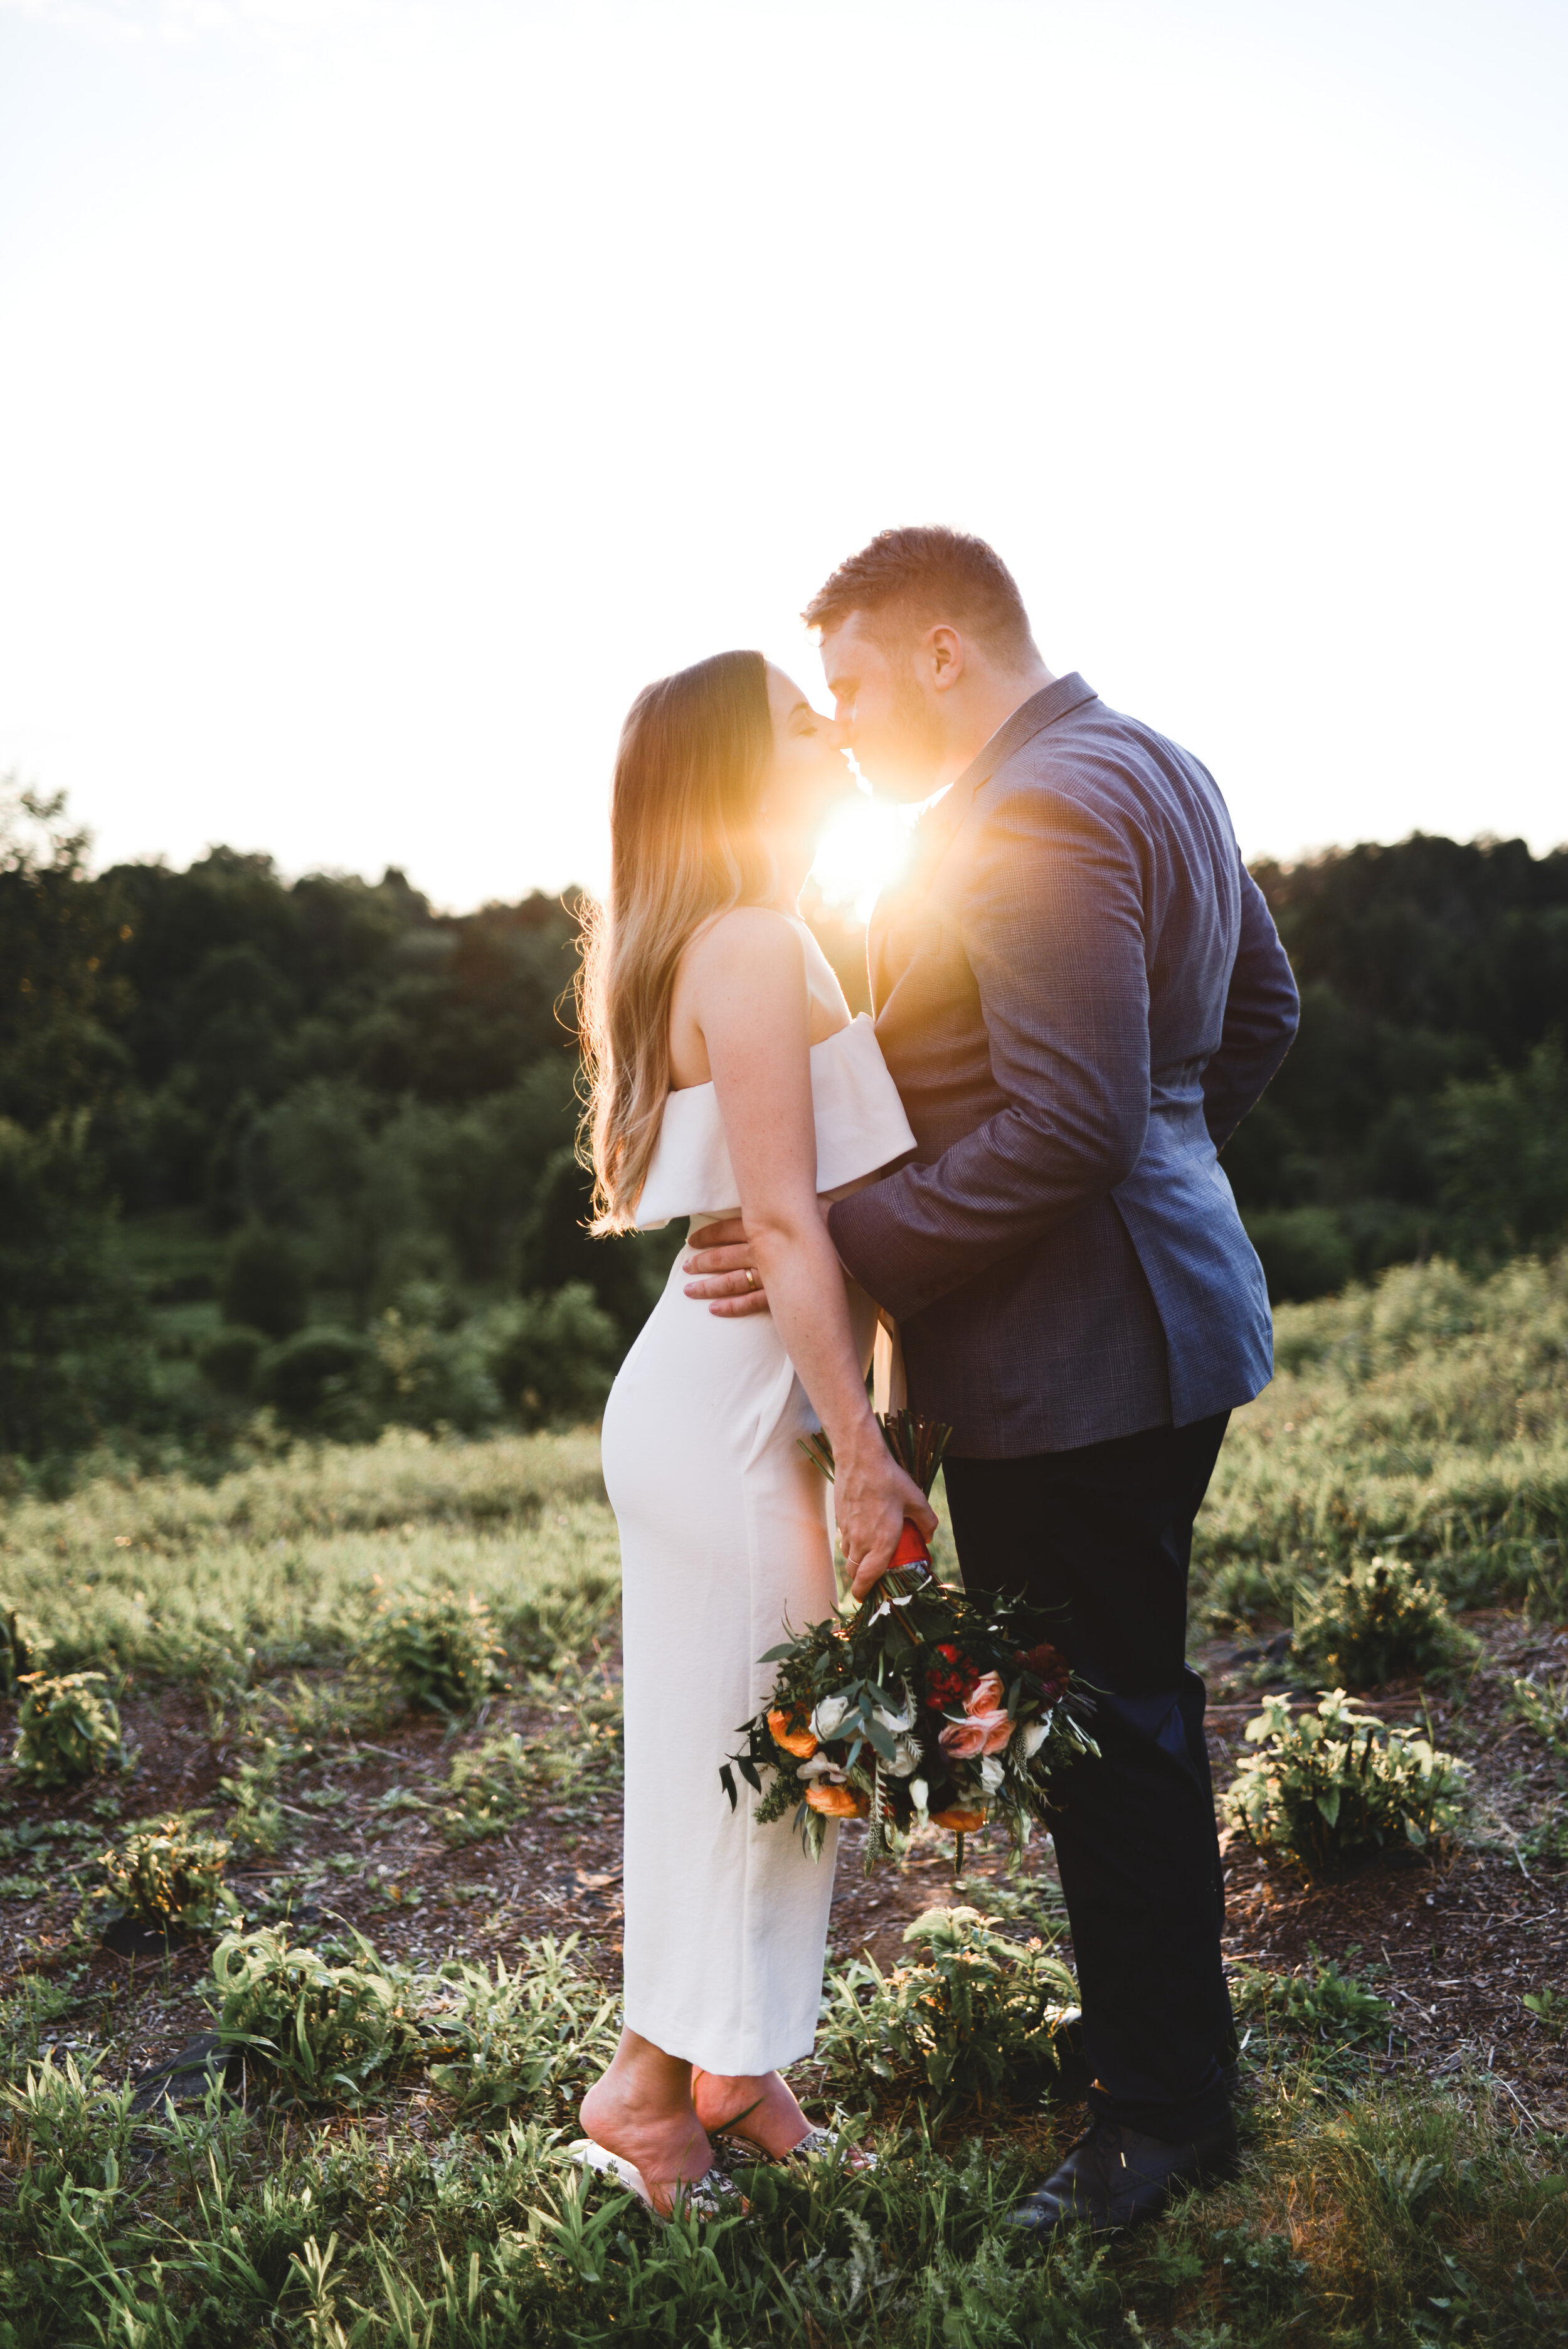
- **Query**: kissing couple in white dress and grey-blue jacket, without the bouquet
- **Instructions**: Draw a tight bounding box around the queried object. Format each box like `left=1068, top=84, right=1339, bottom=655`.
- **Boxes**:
left=570, top=529, right=1296, bottom=2239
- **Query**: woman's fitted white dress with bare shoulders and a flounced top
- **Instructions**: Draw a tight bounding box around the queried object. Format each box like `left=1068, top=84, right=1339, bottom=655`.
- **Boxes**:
left=603, top=1015, right=916, bottom=2072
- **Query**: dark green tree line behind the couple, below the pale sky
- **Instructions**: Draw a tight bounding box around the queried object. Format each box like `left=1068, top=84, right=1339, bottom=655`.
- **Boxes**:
left=0, top=794, right=1568, bottom=1461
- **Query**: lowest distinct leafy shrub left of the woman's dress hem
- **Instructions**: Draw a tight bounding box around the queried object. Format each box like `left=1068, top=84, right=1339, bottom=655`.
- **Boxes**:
left=211, top=1926, right=420, bottom=2105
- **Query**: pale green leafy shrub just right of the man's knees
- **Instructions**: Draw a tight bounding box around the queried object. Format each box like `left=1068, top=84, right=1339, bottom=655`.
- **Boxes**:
left=1226, top=1689, right=1465, bottom=1877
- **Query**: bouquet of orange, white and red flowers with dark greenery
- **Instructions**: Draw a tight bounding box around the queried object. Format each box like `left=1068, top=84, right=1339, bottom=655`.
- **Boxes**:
left=718, top=1412, right=1098, bottom=1875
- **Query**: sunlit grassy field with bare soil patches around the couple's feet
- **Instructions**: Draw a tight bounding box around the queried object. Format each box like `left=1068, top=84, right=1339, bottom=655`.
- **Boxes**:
left=0, top=1259, right=1568, bottom=2349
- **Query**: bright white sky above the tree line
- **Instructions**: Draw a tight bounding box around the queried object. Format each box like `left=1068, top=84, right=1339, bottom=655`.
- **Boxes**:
left=0, top=0, right=1568, bottom=907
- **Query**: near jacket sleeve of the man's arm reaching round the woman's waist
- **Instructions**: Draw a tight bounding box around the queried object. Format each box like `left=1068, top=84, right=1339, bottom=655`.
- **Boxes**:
left=829, top=782, right=1148, bottom=1320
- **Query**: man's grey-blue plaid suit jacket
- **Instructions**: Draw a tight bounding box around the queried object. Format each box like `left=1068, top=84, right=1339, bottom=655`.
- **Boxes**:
left=831, top=674, right=1298, bottom=1459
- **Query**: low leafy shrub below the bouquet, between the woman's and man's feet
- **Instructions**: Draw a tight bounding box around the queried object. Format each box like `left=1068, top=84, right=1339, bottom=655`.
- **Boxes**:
left=817, top=1907, right=1078, bottom=2096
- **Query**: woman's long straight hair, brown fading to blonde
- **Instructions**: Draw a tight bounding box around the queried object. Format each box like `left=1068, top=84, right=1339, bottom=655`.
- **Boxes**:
left=578, top=653, right=777, bottom=1238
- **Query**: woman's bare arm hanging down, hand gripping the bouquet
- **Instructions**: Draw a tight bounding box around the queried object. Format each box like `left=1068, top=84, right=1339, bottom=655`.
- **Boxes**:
left=686, top=907, right=936, bottom=1598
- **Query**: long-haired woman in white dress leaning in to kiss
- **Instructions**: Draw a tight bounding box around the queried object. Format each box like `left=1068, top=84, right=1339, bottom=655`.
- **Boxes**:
left=582, top=653, right=936, bottom=2213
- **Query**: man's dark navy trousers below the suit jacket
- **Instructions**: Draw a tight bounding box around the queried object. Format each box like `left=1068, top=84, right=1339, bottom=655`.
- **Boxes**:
left=946, top=1412, right=1235, bottom=2140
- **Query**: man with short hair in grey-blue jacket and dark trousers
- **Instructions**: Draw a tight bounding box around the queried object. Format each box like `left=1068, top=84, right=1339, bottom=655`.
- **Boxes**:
left=690, top=529, right=1296, bottom=2239
